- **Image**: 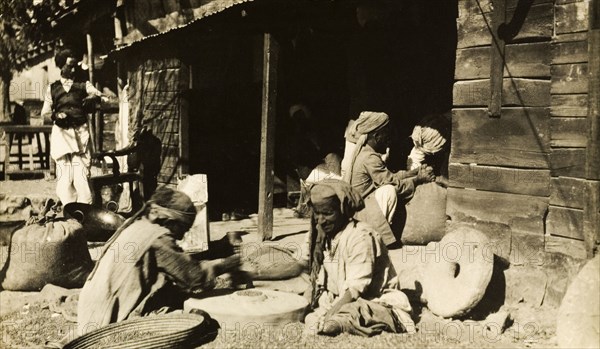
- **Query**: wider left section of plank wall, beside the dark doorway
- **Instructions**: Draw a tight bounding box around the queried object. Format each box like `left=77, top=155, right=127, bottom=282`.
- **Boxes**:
left=447, top=0, right=554, bottom=242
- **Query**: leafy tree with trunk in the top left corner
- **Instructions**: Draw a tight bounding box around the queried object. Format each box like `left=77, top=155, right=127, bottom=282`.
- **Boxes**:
left=0, top=0, right=60, bottom=122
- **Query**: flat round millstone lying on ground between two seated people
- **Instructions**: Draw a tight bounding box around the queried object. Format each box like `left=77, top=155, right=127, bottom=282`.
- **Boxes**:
left=183, top=289, right=308, bottom=329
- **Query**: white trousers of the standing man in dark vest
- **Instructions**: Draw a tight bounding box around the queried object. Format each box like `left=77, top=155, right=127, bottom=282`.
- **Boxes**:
left=56, top=153, right=92, bottom=205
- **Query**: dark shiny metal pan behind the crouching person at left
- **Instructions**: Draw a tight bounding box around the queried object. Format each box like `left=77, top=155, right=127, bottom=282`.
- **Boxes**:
left=63, top=202, right=125, bottom=241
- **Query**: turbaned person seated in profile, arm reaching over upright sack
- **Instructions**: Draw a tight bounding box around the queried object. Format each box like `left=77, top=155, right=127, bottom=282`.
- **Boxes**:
left=342, top=111, right=435, bottom=246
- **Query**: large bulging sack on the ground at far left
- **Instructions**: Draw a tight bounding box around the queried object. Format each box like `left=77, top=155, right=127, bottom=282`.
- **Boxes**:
left=0, top=219, right=94, bottom=291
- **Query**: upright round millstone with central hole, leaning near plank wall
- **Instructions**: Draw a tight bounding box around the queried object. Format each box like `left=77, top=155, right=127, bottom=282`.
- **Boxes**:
left=423, top=227, right=494, bottom=318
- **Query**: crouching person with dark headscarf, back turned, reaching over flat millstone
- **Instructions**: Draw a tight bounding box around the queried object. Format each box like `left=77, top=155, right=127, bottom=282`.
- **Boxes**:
left=77, top=187, right=240, bottom=334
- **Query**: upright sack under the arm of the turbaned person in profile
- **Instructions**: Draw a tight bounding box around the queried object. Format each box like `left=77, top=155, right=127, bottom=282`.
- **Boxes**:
left=401, top=183, right=447, bottom=245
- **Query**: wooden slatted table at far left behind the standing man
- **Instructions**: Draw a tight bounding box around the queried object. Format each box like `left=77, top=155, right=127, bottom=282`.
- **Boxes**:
left=0, top=125, right=54, bottom=180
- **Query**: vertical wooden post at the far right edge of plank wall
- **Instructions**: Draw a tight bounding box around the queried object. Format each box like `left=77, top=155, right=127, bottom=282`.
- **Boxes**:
left=583, top=0, right=600, bottom=258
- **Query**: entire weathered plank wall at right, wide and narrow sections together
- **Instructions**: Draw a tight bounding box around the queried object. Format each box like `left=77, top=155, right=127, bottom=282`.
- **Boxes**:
left=447, top=0, right=588, bottom=256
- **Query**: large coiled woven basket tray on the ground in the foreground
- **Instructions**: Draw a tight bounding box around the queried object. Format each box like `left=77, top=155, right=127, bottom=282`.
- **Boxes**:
left=63, top=314, right=218, bottom=349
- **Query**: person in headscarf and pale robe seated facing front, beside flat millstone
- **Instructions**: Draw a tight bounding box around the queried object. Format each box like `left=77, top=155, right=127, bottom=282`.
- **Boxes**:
left=305, top=179, right=414, bottom=336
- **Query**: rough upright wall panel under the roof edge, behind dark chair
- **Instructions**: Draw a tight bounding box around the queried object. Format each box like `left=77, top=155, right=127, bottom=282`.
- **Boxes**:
left=129, top=58, right=189, bottom=187
